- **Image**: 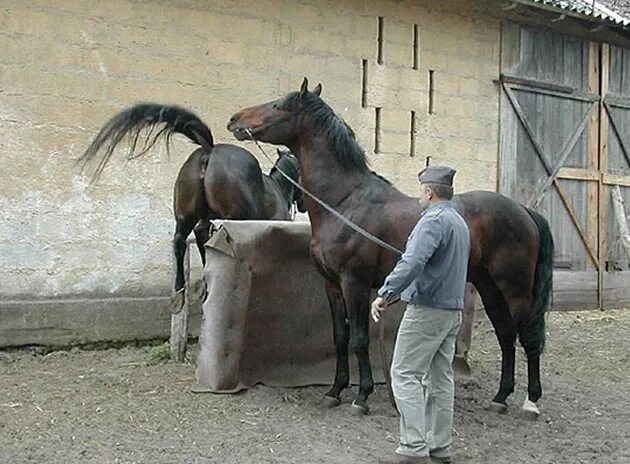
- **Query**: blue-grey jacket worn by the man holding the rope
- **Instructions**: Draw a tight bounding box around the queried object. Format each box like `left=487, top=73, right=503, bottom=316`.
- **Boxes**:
left=378, top=201, right=470, bottom=309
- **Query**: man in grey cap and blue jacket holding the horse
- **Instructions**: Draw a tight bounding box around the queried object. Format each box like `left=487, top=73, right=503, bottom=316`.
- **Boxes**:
left=371, top=166, right=470, bottom=463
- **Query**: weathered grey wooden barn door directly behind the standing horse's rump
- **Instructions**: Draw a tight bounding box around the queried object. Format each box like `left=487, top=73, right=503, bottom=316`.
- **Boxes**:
left=499, top=24, right=604, bottom=309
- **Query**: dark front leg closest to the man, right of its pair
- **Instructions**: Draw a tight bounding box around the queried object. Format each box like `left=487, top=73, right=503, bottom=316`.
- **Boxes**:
left=341, top=279, right=374, bottom=414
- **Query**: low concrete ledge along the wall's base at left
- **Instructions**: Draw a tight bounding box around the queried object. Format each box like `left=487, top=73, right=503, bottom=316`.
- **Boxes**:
left=0, top=296, right=201, bottom=348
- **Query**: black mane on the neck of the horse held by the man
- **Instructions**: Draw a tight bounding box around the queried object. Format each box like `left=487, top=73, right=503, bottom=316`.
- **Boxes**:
left=295, top=92, right=369, bottom=172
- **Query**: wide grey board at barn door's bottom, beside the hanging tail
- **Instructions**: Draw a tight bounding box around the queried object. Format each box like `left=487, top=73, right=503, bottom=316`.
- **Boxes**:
left=551, top=271, right=599, bottom=310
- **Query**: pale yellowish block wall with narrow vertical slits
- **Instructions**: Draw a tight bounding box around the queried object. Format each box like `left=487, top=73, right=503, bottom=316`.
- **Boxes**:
left=0, top=0, right=499, bottom=340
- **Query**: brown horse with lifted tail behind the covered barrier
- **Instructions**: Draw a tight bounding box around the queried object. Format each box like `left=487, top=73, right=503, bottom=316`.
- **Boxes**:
left=83, top=103, right=305, bottom=311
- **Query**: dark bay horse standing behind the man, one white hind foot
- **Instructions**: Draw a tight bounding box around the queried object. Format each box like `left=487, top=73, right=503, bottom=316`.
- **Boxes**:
left=228, top=79, right=554, bottom=415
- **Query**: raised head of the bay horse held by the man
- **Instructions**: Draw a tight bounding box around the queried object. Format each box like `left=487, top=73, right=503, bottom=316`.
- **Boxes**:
left=227, top=78, right=322, bottom=146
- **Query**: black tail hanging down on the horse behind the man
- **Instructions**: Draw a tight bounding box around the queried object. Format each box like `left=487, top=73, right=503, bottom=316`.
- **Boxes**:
left=519, top=208, right=554, bottom=356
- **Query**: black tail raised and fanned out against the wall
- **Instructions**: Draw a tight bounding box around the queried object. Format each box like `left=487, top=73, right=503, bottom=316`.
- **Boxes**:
left=79, top=103, right=214, bottom=180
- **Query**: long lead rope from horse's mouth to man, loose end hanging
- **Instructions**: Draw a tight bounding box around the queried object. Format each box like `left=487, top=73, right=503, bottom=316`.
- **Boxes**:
left=245, top=129, right=402, bottom=413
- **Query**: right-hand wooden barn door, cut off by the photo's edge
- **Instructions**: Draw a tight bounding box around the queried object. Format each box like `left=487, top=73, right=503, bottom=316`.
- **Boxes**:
left=600, top=46, right=630, bottom=308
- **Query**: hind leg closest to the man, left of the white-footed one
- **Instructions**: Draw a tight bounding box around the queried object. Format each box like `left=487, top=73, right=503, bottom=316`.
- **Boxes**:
left=475, top=276, right=516, bottom=412
